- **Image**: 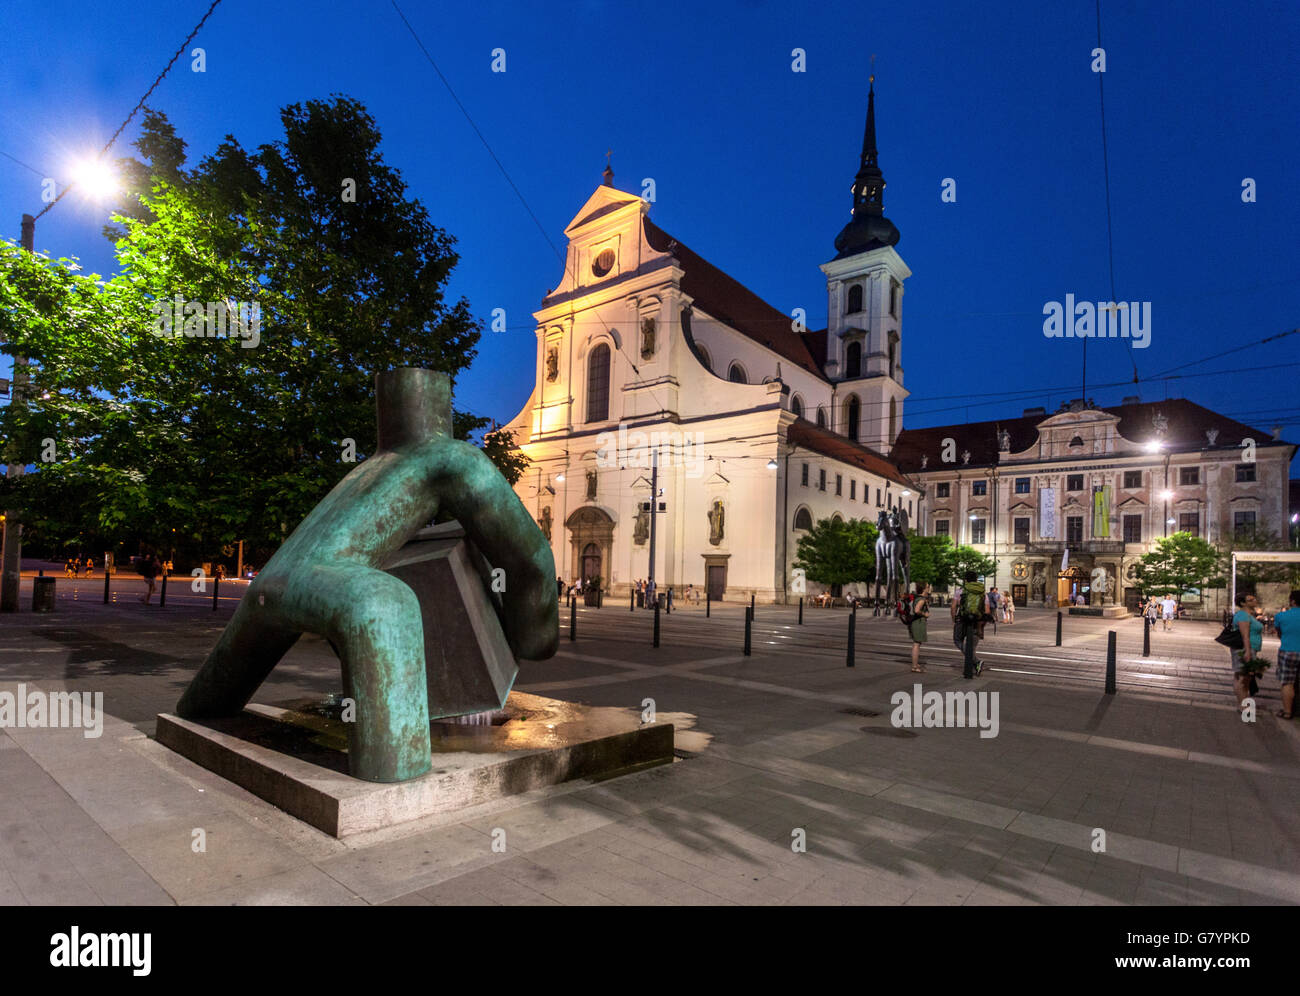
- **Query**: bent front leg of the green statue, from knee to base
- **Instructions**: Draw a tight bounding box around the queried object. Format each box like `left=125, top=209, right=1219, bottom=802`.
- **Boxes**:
left=302, top=564, right=433, bottom=781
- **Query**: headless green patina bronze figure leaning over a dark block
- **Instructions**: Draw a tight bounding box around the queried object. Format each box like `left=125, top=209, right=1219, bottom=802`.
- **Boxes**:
left=176, top=369, right=559, bottom=781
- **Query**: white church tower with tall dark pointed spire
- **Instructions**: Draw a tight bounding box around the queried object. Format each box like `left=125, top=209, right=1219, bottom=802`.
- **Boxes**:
left=822, top=75, right=911, bottom=455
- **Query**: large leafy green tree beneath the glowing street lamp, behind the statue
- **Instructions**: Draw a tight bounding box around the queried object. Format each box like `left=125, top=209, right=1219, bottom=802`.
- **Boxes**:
left=0, top=96, right=520, bottom=560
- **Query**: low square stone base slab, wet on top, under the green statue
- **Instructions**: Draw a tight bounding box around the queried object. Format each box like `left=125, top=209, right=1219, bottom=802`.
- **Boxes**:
left=156, top=692, right=673, bottom=837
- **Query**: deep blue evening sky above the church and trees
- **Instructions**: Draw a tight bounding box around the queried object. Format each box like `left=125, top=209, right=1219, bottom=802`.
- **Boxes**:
left=0, top=0, right=1300, bottom=476
